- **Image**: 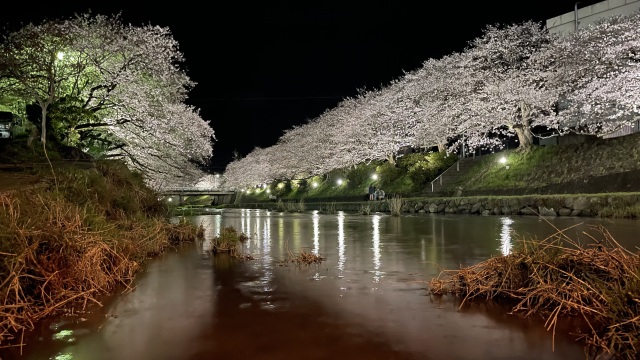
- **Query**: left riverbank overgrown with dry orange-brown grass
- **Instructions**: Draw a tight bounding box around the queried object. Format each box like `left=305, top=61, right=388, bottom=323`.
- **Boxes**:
left=0, top=161, right=201, bottom=347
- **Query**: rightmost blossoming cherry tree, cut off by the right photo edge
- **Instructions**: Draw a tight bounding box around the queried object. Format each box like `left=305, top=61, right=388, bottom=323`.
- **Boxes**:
left=552, top=11, right=640, bottom=135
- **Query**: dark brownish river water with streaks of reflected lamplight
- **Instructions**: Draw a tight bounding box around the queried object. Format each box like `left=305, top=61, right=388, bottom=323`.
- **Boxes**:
left=0, top=210, right=640, bottom=360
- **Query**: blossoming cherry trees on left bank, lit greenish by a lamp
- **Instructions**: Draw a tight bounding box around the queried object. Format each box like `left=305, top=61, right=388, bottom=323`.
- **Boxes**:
left=0, top=14, right=214, bottom=187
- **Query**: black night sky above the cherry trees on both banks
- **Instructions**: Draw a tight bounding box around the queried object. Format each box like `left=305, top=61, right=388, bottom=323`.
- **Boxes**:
left=0, top=0, right=599, bottom=172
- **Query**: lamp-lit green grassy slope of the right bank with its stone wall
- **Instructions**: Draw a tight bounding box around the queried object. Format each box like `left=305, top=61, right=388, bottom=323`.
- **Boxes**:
left=221, top=133, right=640, bottom=219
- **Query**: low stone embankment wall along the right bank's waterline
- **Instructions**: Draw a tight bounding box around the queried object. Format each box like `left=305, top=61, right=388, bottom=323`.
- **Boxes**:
left=238, top=193, right=640, bottom=217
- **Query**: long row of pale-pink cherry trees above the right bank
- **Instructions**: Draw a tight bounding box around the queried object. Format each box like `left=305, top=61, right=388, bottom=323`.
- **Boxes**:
left=224, top=13, right=640, bottom=188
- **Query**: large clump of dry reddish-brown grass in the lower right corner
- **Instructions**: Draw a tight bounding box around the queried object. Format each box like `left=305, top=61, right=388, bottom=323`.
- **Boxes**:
left=430, top=227, right=640, bottom=359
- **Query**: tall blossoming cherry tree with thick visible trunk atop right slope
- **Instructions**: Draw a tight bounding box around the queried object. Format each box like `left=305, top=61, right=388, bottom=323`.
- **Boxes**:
left=458, top=21, right=561, bottom=150
